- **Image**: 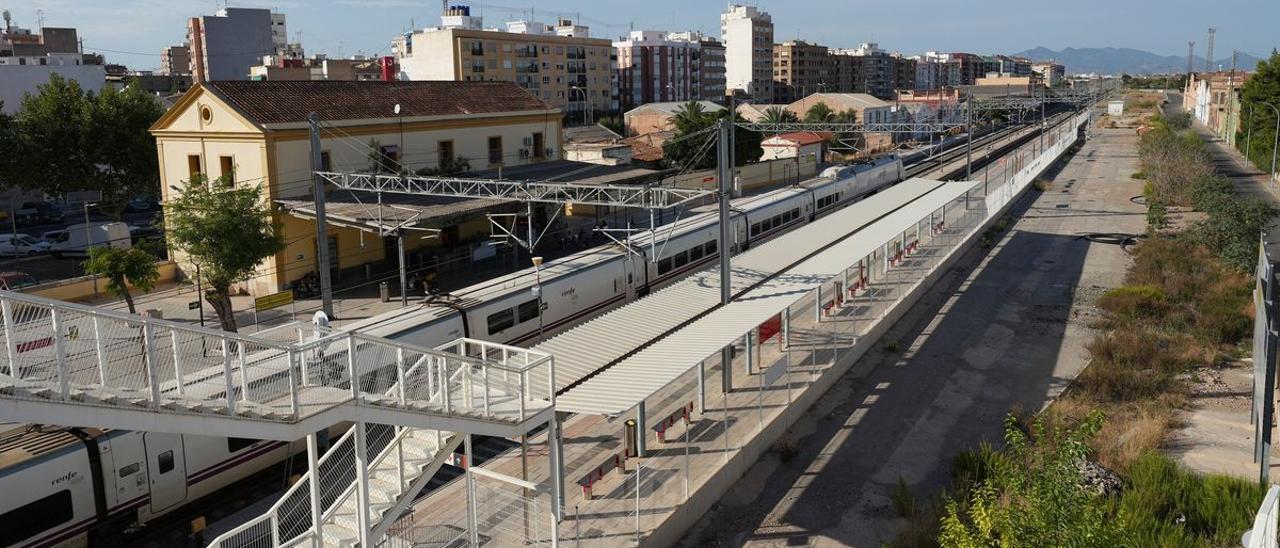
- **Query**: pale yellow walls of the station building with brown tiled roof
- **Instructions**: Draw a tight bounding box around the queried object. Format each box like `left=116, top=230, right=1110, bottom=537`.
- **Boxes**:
left=152, top=87, right=562, bottom=294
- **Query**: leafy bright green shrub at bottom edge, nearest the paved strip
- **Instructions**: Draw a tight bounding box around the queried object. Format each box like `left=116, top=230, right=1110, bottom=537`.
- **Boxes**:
left=938, top=411, right=1125, bottom=548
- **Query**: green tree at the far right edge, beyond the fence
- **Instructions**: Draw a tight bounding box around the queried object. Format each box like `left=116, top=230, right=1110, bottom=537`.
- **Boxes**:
left=1235, top=51, right=1280, bottom=172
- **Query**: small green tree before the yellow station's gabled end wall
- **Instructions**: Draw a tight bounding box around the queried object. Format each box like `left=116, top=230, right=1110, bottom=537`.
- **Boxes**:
left=165, top=175, right=284, bottom=332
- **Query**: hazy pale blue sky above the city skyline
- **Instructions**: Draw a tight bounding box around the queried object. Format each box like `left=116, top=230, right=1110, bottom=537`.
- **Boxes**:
left=12, top=0, right=1280, bottom=69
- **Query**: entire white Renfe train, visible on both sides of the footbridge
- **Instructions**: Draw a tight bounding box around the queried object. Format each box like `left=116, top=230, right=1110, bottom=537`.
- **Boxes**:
left=0, top=156, right=904, bottom=547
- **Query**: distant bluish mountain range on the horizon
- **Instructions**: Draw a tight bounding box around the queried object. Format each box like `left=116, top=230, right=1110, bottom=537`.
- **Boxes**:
left=1014, top=47, right=1260, bottom=74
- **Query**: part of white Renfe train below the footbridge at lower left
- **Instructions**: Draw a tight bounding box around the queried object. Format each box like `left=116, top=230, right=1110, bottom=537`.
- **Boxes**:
left=0, top=424, right=344, bottom=547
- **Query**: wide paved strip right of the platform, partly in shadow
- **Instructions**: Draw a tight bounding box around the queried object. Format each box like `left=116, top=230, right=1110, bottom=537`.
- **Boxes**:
left=685, top=119, right=1144, bottom=547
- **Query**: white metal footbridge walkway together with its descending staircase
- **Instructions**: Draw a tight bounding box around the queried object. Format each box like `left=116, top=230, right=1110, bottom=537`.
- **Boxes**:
left=0, top=291, right=559, bottom=548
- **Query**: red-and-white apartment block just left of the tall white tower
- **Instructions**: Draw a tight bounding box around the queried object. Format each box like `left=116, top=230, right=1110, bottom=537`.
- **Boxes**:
left=613, top=31, right=724, bottom=110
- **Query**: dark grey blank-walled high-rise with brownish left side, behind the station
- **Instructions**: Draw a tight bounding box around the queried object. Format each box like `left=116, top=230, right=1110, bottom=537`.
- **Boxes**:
left=187, top=8, right=288, bottom=82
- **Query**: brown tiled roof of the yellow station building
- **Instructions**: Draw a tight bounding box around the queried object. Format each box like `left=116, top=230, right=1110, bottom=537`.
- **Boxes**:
left=204, top=81, right=552, bottom=125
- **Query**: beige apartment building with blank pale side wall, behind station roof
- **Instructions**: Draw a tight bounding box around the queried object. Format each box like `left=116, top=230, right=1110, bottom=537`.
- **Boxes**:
left=392, top=6, right=618, bottom=119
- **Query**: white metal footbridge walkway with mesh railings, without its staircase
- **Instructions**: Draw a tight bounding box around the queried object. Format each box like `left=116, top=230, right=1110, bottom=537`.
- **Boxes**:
left=0, top=292, right=552, bottom=440
